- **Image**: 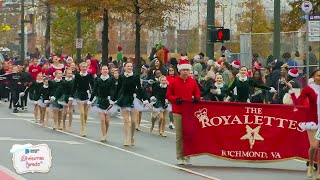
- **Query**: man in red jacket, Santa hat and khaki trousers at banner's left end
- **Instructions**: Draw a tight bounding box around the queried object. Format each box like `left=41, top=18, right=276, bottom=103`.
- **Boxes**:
left=166, top=60, right=200, bottom=165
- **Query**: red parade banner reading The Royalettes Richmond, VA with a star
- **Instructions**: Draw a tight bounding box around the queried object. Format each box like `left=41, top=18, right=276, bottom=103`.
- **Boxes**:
left=182, top=101, right=309, bottom=161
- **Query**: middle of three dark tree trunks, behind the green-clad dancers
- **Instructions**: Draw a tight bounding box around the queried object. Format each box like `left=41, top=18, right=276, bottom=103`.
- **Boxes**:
left=101, top=9, right=109, bottom=65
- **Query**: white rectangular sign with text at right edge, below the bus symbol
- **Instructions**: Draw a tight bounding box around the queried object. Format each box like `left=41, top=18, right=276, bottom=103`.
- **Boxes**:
left=308, top=14, right=320, bottom=42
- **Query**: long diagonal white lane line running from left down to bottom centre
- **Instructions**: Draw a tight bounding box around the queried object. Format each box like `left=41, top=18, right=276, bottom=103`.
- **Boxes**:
left=13, top=119, right=220, bottom=180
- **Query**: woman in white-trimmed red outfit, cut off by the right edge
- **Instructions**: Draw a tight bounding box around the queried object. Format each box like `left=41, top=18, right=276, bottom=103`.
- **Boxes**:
left=286, top=69, right=320, bottom=180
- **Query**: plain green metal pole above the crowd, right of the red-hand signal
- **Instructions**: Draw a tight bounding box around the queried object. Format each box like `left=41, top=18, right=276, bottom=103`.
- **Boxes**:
left=273, top=0, right=281, bottom=60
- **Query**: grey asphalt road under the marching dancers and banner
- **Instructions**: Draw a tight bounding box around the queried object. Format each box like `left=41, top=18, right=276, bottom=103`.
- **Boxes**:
left=0, top=103, right=307, bottom=180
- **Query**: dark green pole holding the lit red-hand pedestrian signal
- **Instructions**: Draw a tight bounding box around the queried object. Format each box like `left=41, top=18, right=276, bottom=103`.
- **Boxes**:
left=206, top=0, right=215, bottom=59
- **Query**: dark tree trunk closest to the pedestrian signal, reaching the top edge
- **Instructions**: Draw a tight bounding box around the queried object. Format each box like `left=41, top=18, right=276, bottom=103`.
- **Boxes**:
left=134, top=0, right=142, bottom=75
